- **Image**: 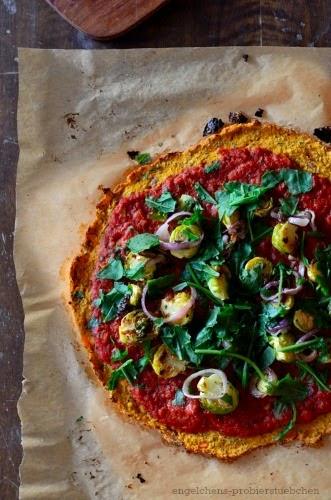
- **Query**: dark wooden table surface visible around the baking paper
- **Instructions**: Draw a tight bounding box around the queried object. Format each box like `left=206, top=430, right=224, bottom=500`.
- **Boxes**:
left=0, top=0, right=331, bottom=500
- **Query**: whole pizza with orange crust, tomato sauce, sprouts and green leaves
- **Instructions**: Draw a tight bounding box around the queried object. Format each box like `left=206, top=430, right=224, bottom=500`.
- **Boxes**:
left=70, top=121, right=331, bottom=460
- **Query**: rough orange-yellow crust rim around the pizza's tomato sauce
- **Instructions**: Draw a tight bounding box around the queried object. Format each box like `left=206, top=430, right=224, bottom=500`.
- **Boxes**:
left=70, top=121, right=331, bottom=460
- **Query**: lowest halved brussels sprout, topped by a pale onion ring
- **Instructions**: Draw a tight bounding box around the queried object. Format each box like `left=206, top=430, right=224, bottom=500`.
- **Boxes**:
left=197, top=373, right=239, bottom=415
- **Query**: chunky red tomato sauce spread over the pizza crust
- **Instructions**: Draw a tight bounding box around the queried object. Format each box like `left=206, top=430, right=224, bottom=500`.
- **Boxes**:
left=92, top=148, right=331, bottom=437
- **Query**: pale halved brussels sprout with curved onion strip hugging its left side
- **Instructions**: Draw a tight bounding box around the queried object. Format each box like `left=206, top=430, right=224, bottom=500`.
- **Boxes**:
left=160, top=291, right=194, bottom=325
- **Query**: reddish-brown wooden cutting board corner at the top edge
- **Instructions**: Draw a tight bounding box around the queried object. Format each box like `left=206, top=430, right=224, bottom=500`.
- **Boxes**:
left=46, top=0, right=168, bottom=39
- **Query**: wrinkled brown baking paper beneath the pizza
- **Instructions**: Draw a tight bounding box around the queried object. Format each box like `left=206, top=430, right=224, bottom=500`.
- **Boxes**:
left=15, top=47, right=331, bottom=500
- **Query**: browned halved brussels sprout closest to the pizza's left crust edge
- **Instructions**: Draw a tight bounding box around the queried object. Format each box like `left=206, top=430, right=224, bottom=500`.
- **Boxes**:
left=119, top=309, right=159, bottom=345
